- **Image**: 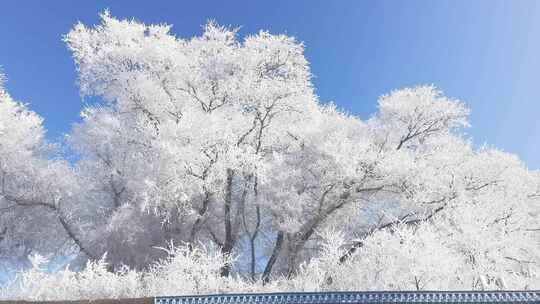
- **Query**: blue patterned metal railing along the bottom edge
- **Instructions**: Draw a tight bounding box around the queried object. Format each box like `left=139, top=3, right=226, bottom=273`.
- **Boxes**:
left=154, top=290, right=540, bottom=304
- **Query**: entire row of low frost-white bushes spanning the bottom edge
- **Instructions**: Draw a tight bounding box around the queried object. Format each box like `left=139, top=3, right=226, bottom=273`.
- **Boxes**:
left=0, top=220, right=540, bottom=300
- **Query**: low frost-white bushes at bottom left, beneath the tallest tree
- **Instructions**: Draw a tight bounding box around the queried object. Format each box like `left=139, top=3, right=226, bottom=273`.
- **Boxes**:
left=0, top=245, right=249, bottom=301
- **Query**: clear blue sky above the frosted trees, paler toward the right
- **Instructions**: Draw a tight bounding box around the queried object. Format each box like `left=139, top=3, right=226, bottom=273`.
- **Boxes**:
left=0, top=0, right=540, bottom=168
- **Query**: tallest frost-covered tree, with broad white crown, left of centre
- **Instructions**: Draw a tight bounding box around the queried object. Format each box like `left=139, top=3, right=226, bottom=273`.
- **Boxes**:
left=66, top=14, right=318, bottom=274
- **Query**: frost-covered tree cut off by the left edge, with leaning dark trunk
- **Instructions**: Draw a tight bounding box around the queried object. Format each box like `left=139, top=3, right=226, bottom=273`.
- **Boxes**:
left=0, top=72, right=94, bottom=270
